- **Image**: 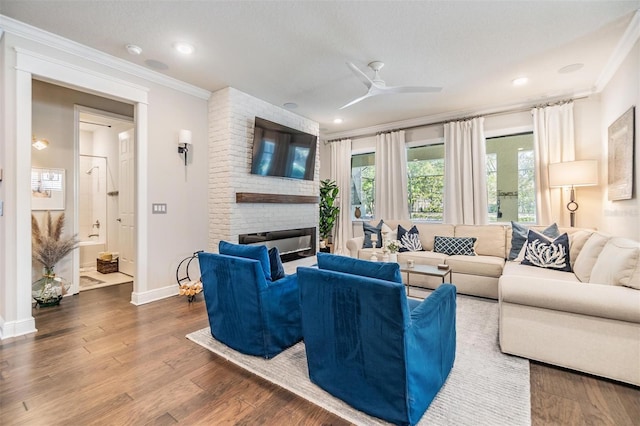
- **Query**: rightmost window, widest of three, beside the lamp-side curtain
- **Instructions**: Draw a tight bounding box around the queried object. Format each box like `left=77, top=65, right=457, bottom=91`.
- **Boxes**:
left=486, top=133, right=536, bottom=223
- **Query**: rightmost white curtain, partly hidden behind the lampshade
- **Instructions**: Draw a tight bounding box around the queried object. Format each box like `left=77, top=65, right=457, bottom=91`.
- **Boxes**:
left=531, top=102, right=575, bottom=224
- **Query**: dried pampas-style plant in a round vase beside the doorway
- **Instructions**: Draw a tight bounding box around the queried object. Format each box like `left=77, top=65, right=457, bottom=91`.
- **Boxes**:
left=31, top=212, right=78, bottom=306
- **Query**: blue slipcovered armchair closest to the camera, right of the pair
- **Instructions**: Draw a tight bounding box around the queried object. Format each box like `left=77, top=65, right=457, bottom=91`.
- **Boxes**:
left=298, top=253, right=456, bottom=425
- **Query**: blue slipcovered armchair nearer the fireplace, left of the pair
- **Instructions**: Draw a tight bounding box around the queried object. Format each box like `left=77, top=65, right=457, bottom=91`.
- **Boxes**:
left=198, top=242, right=302, bottom=358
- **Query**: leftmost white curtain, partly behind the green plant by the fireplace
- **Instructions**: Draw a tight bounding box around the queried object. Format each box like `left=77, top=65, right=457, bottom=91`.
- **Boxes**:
left=331, top=139, right=351, bottom=254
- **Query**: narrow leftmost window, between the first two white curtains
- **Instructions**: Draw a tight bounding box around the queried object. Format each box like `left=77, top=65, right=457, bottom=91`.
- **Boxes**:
left=351, top=152, right=376, bottom=219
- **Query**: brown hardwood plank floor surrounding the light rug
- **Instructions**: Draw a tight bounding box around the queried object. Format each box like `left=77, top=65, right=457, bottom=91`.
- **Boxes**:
left=0, top=284, right=640, bottom=425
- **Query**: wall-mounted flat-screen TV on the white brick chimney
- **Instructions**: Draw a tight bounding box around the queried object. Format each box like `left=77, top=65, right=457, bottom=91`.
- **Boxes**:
left=251, top=117, right=318, bottom=180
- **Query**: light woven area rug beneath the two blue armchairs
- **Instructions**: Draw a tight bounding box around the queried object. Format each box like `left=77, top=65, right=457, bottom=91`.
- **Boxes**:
left=187, top=295, right=531, bottom=426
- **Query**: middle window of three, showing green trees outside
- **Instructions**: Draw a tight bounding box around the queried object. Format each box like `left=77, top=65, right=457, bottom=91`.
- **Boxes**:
left=407, top=144, right=444, bottom=222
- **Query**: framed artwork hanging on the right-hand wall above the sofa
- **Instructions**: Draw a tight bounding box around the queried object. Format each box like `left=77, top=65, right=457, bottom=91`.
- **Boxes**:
left=607, top=107, right=635, bottom=201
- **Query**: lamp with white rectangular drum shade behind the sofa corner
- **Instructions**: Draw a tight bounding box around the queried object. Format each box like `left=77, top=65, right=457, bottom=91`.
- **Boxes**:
left=549, top=160, right=598, bottom=228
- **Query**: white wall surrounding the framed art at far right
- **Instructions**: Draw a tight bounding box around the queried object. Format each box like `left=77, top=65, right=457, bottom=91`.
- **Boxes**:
left=600, top=42, right=640, bottom=240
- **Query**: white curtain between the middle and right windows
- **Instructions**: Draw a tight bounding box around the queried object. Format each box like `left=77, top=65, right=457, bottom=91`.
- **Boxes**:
left=444, top=117, right=488, bottom=225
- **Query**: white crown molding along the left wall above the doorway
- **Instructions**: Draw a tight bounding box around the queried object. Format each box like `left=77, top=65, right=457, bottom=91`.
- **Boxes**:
left=0, top=15, right=211, bottom=100
